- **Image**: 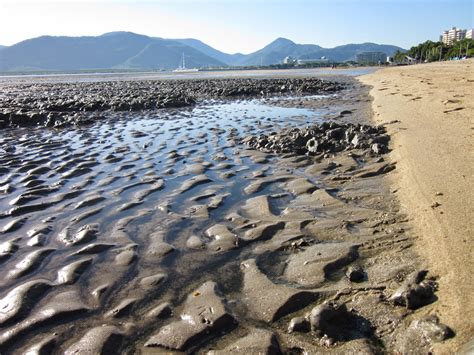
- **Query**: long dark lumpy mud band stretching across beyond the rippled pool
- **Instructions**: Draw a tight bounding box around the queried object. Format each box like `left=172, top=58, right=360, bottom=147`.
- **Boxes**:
left=0, top=78, right=342, bottom=128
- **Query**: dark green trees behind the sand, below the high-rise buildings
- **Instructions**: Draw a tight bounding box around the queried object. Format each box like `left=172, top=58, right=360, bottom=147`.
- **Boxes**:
left=393, top=38, right=474, bottom=63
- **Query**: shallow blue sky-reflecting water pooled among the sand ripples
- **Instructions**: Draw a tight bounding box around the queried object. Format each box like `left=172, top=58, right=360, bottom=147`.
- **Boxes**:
left=0, top=100, right=328, bottom=221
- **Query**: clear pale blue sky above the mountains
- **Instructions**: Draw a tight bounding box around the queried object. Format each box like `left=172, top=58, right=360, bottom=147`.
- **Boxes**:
left=0, top=0, right=474, bottom=53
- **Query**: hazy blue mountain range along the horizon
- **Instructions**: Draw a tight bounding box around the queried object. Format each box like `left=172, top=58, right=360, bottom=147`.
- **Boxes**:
left=0, top=32, right=402, bottom=72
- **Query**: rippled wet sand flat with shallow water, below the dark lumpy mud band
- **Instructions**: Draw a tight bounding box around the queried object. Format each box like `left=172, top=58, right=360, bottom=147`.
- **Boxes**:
left=0, top=79, right=448, bottom=353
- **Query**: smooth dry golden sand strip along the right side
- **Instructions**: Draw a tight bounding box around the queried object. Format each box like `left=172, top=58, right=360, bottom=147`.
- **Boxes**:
left=360, top=60, right=474, bottom=352
